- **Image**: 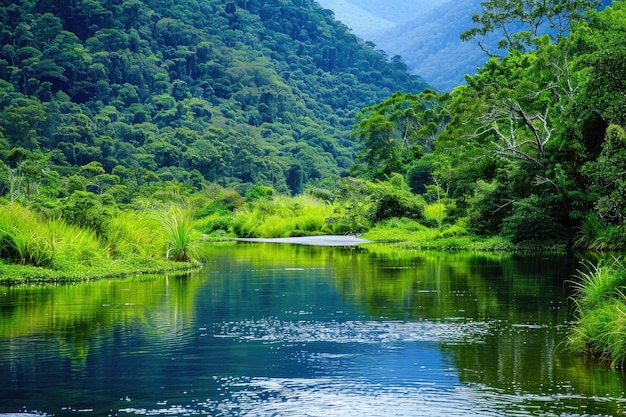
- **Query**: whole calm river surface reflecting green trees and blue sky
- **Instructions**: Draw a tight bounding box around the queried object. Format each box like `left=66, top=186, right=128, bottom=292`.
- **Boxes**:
left=0, top=244, right=626, bottom=417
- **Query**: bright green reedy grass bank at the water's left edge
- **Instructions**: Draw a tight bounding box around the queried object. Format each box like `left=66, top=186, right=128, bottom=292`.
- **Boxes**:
left=0, top=204, right=201, bottom=285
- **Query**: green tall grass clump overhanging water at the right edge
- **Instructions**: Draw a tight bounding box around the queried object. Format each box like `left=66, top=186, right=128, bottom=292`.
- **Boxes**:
left=567, top=258, right=626, bottom=367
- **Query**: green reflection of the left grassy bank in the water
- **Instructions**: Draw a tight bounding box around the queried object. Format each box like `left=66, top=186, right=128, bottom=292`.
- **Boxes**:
left=0, top=273, right=201, bottom=371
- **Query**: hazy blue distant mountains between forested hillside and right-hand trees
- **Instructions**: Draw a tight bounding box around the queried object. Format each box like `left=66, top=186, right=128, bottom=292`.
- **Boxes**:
left=318, top=0, right=611, bottom=91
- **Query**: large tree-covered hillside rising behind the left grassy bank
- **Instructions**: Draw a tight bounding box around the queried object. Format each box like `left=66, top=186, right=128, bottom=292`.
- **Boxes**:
left=0, top=0, right=425, bottom=203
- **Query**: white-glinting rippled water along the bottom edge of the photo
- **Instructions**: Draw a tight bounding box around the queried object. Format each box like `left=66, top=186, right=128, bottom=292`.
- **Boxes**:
left=119, top=377, right=626, bottom=417
